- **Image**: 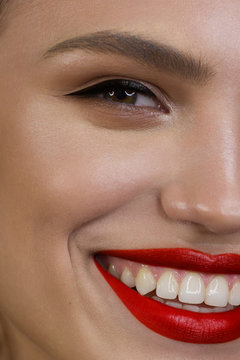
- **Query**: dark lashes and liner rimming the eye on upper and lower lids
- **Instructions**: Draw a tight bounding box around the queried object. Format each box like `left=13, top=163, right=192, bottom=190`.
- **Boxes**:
left=66, top=79, right=169, bottom=113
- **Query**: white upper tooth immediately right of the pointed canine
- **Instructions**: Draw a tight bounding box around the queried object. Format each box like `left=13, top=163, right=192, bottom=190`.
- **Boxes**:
left=156, top=271, right=179, bottom=299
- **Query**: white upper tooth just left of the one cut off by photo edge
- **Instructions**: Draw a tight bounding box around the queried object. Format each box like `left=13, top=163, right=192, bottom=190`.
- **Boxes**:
left=204, top=275, right=229, bottom=306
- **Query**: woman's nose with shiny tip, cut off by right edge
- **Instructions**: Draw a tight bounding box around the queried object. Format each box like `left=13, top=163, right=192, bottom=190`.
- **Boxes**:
left=161, top=113, right=240, bottom=234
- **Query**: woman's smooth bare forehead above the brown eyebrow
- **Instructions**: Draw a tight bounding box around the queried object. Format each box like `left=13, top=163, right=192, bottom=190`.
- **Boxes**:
left=0, top=0, right=240, bottom=71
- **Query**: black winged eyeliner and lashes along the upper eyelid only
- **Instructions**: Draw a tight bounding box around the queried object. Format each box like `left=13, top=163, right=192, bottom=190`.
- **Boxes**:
left=66, top=79, right=157, bottom=99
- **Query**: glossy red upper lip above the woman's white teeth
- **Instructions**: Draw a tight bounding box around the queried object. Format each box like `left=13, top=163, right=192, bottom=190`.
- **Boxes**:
left=97, top=248, right=240, bottom=274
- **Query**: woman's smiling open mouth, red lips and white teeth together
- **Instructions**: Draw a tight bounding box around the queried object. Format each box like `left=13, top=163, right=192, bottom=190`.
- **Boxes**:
left=94, top=248, right=240, bottom=344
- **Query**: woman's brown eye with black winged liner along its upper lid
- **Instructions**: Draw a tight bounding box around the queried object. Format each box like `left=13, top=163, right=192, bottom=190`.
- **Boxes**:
left=66, top=79, right=169, bottom=110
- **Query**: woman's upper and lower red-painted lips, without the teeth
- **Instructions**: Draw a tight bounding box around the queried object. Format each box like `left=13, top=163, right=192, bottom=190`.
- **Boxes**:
left=95, top=248, right=240, bottom=344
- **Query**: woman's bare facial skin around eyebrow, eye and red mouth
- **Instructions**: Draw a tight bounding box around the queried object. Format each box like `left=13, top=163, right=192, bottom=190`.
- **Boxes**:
left=0, top=0, right=240, bottom=360
